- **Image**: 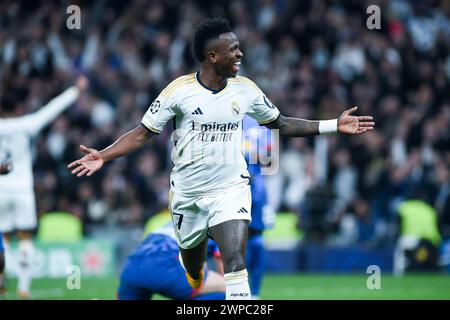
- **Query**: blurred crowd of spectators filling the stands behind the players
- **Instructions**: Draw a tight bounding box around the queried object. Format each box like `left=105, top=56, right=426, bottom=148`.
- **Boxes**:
left=0, top=0, right=450, bottom=245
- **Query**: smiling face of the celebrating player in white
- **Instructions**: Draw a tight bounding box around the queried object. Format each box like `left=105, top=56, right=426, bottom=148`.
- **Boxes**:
left=211, top=32, right=243, bottom=78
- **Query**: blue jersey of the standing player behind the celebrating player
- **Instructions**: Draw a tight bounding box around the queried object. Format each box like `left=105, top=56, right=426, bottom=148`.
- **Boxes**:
left=243, top=116, right=271, bottom=231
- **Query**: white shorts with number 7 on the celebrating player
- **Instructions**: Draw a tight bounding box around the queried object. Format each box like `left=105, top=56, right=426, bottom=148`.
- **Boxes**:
left=169, top=185, right=252, bottom=249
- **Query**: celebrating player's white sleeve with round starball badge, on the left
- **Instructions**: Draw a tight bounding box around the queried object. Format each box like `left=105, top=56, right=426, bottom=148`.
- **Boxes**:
left=141, top=94, right=176, bottom=133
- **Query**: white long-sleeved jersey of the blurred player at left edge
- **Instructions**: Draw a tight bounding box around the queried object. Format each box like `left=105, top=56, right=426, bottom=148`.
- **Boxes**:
left=0, top=87, right=80, bottom=193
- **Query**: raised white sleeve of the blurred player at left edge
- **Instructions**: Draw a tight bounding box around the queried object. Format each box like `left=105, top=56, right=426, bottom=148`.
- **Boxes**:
left=21, top=87, right=80, bottom=135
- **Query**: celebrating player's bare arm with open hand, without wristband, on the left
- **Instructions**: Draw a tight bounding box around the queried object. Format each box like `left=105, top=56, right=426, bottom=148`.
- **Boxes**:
left=67, top=125, right=153, bottom=177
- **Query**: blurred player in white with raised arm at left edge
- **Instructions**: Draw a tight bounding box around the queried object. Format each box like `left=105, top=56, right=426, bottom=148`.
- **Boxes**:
left=0, top=76, right=87, bottom=299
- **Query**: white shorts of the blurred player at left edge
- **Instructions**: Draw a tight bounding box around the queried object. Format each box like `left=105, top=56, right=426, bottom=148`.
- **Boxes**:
left=0, top=192, right=37, bottom=233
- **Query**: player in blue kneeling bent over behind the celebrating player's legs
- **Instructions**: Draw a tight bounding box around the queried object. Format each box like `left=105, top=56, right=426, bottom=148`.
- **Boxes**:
left=117, top=222, right=225, bottom=300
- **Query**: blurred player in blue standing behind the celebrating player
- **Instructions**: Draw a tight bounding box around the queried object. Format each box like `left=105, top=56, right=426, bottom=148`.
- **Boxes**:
left=243, top=116, right=275, bottom=299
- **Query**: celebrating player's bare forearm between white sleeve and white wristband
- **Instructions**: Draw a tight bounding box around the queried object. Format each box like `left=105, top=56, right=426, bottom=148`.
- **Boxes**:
left=268, top=115, right=319, bottom=137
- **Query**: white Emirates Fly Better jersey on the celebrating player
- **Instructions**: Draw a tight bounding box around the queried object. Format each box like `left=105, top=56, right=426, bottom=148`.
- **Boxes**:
left=142, top=72, right=280, bottom=196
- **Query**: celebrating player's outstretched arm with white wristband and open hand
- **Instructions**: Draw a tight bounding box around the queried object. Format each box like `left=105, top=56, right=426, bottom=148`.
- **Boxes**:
left=267, top=107, right=375, bottom=137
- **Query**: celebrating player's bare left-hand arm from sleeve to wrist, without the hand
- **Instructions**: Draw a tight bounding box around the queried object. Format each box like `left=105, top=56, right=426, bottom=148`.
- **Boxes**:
left=100, top=126, right=152, bottom=162
